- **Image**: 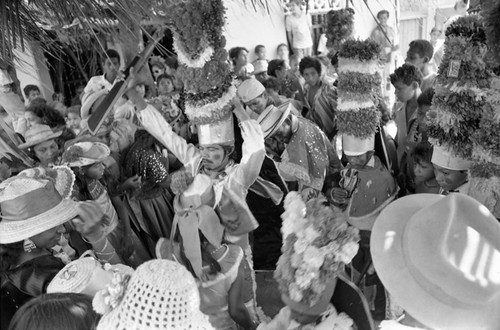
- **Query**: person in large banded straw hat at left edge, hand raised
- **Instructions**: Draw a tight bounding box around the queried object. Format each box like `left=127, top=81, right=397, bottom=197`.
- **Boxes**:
left=0, top=167, right=120, bottom=328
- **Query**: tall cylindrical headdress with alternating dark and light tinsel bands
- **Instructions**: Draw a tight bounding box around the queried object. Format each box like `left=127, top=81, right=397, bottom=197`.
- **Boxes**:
left=337, top=39, right=381, bottom=156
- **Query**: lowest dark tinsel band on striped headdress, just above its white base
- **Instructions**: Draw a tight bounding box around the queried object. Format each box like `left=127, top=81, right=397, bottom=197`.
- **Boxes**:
left=337, top=107, right=380, bottom=139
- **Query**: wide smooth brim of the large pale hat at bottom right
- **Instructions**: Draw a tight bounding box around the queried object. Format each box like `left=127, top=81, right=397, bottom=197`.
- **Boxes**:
left=370, top=194, right=498, bottom=330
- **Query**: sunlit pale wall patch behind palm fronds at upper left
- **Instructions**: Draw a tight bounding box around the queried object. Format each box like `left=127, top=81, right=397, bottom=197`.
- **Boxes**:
left=14, top=42, right=54, bottom=102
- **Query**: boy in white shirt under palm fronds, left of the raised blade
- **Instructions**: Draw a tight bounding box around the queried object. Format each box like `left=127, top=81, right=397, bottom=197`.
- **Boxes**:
left=82, top=49, right=120, bottom=95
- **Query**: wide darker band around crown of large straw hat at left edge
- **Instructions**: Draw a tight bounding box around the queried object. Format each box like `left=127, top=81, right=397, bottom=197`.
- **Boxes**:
left=1, top=183, right=62, bottom=220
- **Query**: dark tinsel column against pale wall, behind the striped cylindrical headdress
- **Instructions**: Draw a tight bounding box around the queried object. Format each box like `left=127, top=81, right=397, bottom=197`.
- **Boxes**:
left=325, top=8, right=354, bottom=50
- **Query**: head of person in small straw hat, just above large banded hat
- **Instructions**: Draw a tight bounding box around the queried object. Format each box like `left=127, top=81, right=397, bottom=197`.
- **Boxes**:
left=19, top=124, right=63, bottom=167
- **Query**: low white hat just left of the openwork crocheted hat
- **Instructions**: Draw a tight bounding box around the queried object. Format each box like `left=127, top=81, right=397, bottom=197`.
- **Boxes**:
left=47, top=257, right=134, bottom=297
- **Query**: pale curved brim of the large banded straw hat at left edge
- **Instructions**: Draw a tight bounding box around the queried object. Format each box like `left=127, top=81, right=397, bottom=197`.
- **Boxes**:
left=0, top=199, right=78, bottom=244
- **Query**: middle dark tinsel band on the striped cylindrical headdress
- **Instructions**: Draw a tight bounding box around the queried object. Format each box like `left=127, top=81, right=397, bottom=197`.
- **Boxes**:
left=337, top=72, right=382, bottom=97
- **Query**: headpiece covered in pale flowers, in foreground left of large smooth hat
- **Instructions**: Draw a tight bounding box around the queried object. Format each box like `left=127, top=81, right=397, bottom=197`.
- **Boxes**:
left=274, top=192, right=359, bottom=306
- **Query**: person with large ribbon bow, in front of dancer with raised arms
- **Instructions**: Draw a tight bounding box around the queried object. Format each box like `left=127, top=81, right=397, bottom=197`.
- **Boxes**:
left=156, top=174, right=256, bottom=330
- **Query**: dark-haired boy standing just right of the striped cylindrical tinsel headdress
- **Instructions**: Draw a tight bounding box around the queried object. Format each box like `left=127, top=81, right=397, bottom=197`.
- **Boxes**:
left=390, top=64, right=423, bottom=162
